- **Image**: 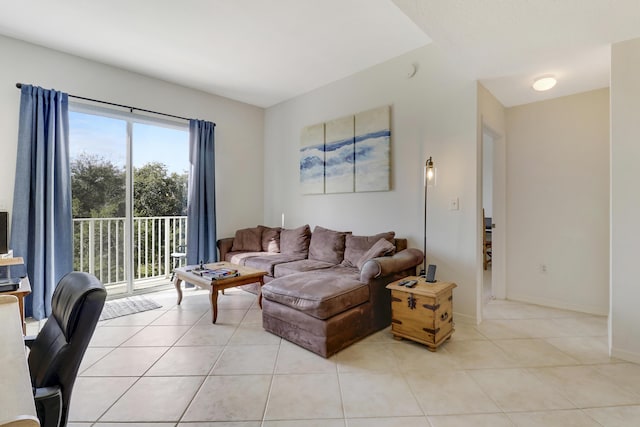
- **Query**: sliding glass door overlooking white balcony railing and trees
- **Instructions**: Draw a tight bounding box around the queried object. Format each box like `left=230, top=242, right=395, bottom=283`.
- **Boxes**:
left=69, top=105, right=188, bottom=295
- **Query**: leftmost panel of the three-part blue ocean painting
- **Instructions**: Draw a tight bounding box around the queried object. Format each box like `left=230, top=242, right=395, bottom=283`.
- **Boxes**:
left=300, top=123, right=324, bottom=194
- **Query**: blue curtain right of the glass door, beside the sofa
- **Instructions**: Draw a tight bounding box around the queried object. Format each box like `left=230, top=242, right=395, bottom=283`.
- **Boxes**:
left=187, top=120, right=218, bottom=265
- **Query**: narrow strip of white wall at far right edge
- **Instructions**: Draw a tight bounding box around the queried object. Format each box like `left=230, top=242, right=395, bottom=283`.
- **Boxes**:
left=609, top=39, right=640, bottom=363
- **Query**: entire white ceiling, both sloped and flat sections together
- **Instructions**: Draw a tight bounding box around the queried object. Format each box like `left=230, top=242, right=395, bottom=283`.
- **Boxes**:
left=0, top=0, right=640, bottom=107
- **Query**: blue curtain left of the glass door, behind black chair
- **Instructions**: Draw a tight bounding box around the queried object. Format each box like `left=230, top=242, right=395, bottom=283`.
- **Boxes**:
left=11, top=85, right=73, bottom=319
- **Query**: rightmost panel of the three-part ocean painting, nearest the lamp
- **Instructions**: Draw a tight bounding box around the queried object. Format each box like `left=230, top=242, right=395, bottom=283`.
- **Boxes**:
left=355, top=106, right=391, bottom=191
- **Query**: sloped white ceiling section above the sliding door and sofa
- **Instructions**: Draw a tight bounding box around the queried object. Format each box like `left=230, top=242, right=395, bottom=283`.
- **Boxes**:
left=0, top=0, right=429, bottom=107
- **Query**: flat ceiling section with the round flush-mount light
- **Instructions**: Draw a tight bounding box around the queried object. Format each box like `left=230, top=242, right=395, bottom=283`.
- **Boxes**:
left=393, top=0, right=640, bottom=107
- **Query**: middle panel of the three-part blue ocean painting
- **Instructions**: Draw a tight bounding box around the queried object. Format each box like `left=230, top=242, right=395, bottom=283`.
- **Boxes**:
left=324, top=116, right=355, bottom=193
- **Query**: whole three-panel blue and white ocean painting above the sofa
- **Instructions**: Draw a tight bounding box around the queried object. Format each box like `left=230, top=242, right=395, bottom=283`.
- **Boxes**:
left=300, top=106, right=391, bottom=194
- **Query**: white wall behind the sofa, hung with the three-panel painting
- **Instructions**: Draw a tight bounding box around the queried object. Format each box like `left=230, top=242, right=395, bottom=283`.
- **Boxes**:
left=265, top=45, right=478, bottom=322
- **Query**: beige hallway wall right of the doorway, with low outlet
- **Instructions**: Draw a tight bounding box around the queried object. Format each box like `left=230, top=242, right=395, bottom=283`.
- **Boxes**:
left=506, top=89, right=609, bottom=315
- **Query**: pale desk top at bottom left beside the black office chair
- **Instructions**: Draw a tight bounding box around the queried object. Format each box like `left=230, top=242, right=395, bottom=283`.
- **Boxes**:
left=0, top=294, right=40, bottom=427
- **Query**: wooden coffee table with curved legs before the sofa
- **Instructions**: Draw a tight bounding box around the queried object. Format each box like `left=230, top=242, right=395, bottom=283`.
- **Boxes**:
left=173, top=261, right=267, bottom=323
